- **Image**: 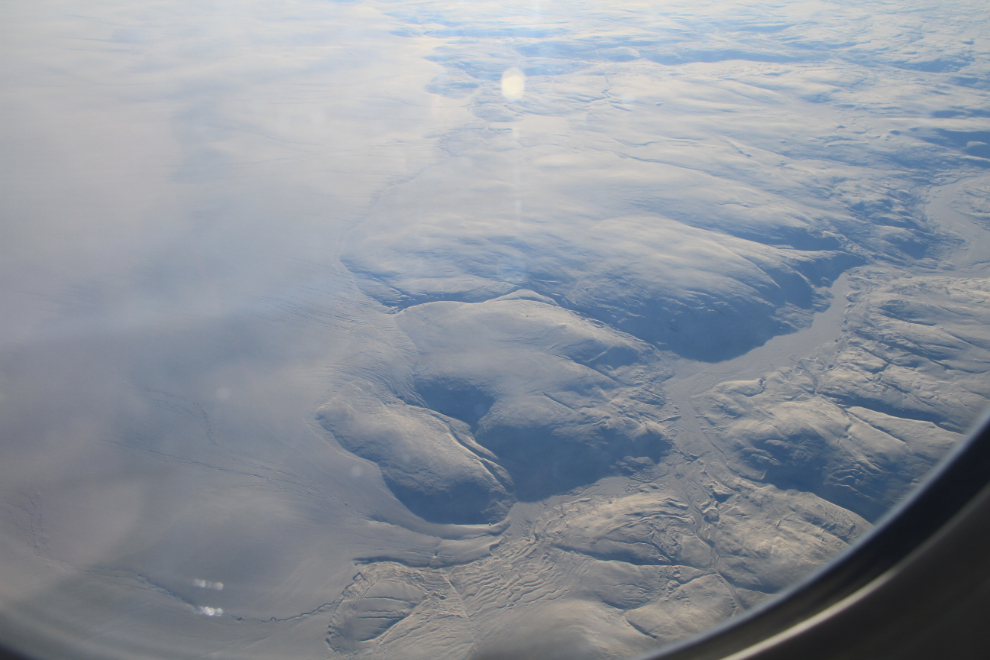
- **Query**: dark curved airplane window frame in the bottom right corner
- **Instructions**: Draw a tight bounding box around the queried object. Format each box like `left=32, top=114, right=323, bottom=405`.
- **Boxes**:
left=641, top=414, right=990, bottom=660
